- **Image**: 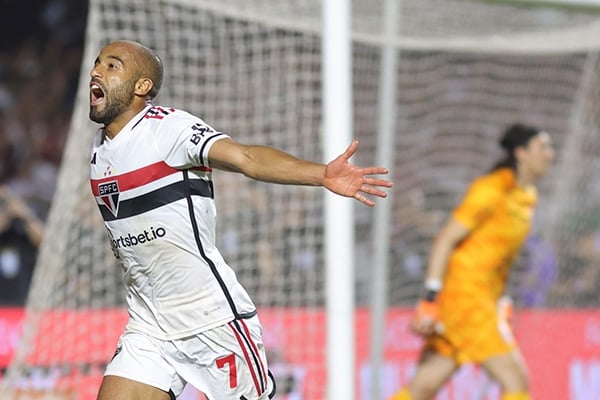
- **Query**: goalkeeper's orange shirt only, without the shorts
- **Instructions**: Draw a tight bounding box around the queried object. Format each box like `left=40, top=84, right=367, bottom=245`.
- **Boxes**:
left=444, top=168, right=537, bottom=298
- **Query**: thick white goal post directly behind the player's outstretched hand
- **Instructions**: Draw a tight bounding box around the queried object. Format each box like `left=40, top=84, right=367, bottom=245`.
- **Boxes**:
left=321, top=0, right=355, bottom=399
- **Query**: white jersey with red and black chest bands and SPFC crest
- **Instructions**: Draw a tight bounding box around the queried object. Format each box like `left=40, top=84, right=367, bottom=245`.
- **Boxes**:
left=90, top=106, right=256, bottom=340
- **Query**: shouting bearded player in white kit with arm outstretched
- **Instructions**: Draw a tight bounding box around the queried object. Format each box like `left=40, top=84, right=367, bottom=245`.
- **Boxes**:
left=89, top=41, right=392, bottom=400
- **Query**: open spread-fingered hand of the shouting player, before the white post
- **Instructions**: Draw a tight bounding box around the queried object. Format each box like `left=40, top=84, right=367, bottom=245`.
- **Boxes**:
left=323, top=140, right=392, bottom=207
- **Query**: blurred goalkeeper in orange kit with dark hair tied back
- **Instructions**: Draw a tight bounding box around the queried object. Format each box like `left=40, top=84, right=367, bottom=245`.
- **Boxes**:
left=390, top=124, right=554, bottom=400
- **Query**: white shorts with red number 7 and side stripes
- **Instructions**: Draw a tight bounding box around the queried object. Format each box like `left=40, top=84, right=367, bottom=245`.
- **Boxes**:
left=104, top=317, right=274, bottom=400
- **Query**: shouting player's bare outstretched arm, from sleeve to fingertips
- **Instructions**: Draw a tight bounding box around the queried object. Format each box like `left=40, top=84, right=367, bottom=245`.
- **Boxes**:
left=209, top=139, right=392, bottom=207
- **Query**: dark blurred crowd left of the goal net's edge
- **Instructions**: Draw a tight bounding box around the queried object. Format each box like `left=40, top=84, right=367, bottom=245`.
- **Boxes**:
left=0, top=0, right=87, bottom=304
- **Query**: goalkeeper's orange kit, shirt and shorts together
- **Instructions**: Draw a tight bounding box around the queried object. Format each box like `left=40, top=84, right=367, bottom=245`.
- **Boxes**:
left=428, top=168, right=537, bottom=363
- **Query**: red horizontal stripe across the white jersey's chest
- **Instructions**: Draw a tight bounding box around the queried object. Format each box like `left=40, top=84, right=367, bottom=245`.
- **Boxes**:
left=90, top=161, right=211, bottom=196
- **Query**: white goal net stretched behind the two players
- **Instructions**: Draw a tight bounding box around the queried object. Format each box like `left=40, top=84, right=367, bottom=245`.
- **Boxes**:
left=0, top=0, right=600, bottom=400
